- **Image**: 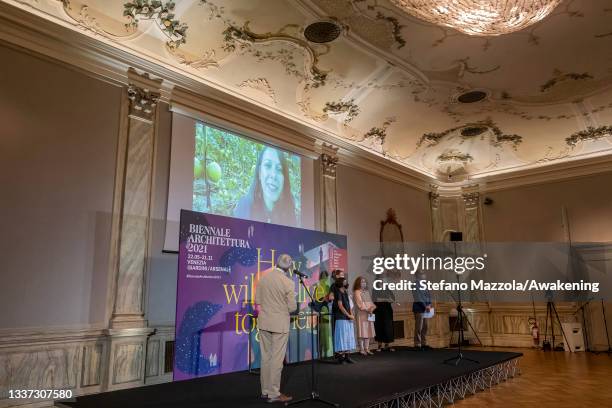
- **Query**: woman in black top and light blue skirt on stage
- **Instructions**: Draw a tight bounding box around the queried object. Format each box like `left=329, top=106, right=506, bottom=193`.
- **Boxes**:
left=333, top=277, right=355, bottom=364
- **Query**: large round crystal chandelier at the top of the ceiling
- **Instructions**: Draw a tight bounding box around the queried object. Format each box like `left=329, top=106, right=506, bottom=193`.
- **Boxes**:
left=391, top=0, right=562, bottom=36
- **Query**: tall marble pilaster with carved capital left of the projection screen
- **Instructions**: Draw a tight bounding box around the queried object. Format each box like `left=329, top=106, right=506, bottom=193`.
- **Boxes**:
left=106, top=69, right=162, bottom=389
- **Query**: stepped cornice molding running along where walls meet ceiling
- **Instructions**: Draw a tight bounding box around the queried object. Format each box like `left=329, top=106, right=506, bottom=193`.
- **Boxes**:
left=0, top=0, right=612, bottom=194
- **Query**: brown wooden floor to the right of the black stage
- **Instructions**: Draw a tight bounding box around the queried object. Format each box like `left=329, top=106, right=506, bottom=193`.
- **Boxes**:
left=455, top=347, right=612, bottom=408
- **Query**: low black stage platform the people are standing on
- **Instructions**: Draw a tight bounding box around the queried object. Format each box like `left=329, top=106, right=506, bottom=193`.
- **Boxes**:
left=63, top=347, right=522, bottom=408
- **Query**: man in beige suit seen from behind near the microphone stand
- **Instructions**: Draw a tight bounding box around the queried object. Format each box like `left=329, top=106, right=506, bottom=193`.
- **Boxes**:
left=255, top=254, right=297, bottom=402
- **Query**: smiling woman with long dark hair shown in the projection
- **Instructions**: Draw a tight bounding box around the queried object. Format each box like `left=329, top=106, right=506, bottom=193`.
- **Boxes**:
left=234, top=147, right=297, bottom=225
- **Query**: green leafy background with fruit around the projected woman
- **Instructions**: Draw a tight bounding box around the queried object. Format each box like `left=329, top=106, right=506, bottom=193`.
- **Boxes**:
left=193, top=123, right=302, bottom=220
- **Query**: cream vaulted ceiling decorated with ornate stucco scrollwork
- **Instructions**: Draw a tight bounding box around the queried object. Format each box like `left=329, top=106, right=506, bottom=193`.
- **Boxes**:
left=12, top=0, right=612, bottom=181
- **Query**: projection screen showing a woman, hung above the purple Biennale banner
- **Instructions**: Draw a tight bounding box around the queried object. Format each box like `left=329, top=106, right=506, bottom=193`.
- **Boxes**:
left=164, top=112, right=314, bottom=252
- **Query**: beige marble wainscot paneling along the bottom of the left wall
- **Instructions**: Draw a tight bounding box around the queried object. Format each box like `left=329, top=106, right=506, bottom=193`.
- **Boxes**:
left=0, top=326, right=174, bottom=407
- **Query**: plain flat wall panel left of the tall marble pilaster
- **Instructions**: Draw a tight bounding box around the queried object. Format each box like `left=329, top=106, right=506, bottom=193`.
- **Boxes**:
left=0, top=46, right=121, bottom=329
